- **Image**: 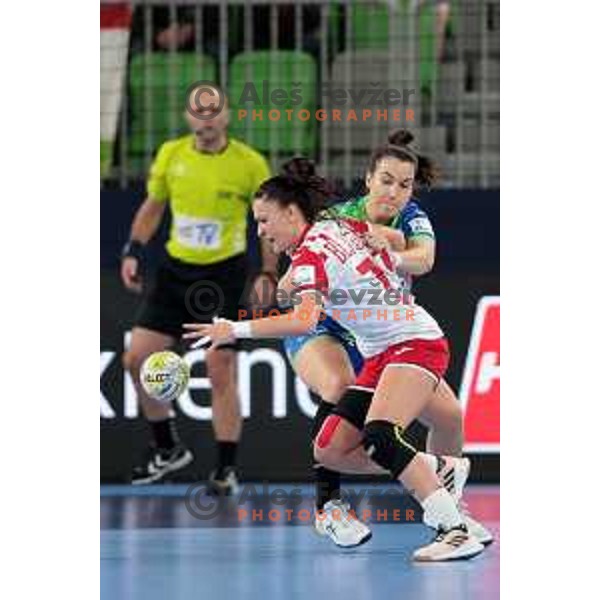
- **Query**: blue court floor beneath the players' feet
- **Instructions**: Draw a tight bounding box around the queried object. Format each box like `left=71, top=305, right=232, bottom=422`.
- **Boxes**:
left=100, top=484, right=500, bottom=600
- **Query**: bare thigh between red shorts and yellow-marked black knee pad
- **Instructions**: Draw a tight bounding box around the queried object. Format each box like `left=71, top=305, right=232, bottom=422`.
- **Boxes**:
left=366, top=365, right=437, bottom=427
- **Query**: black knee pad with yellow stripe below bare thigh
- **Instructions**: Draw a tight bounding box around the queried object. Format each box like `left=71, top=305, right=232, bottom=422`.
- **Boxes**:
left=363, top=421, right=417, bottom=479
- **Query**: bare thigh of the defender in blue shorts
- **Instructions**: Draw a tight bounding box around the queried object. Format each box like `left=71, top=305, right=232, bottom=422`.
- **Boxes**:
left=293, top=335, right=354, bottom=404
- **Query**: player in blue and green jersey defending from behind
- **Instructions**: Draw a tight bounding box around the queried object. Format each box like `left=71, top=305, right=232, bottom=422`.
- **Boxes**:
left=278, top=130, right=493, bottom=547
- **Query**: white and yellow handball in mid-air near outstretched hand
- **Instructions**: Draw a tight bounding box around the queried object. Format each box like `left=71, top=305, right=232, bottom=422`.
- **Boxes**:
left=140, top=351, right=190, bottom=404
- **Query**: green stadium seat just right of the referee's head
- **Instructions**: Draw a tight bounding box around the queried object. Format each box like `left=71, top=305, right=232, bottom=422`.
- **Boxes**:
left=228, top=50, right=317, bottom=154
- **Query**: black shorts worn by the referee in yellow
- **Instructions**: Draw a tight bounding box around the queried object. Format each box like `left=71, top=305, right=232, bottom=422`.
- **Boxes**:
left=136, top=255, right=247, bottom=349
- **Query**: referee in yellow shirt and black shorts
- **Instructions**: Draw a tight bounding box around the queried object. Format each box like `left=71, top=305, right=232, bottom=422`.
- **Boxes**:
left=121, top=87, right=277, bottom=493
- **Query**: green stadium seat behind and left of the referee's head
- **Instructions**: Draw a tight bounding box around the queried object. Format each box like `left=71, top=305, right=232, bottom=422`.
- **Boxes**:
left=128, top=52, right=217, bottom=162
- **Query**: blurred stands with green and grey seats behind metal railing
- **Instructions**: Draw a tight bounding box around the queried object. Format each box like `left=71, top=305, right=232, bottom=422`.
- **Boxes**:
left=101, top=0, right=500, bottom=189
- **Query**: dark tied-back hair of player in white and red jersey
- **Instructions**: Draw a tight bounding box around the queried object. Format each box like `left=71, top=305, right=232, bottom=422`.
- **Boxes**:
left=256, top=156, right=331, bottom=223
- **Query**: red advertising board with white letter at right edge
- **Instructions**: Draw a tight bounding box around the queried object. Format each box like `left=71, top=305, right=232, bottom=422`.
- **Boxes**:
left=460, top=296, right=500, bottom=453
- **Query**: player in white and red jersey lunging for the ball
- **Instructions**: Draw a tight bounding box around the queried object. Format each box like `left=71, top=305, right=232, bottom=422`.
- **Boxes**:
left=184, top=159, right=483, bottom=561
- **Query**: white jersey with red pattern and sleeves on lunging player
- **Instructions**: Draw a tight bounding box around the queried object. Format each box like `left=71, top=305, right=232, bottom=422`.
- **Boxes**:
left=290, top=219, right=444, bottom=358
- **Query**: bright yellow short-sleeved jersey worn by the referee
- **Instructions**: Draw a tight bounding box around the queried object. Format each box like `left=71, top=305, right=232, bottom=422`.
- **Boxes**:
left=148, top=134, right=270, bottom=265
